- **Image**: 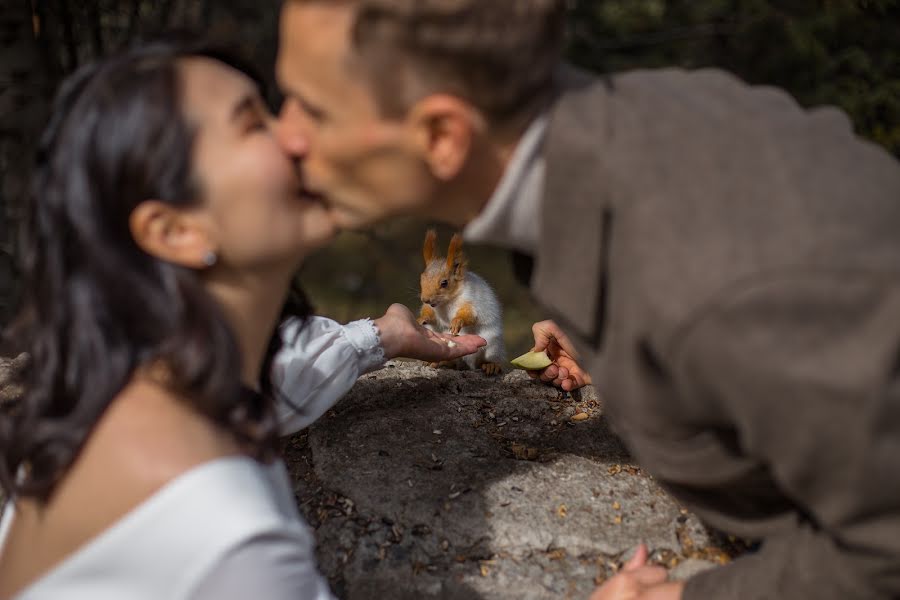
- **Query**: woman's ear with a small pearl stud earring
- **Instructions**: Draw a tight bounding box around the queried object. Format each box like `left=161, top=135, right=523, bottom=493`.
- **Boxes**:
left=128, top=200, right=215, bottom=269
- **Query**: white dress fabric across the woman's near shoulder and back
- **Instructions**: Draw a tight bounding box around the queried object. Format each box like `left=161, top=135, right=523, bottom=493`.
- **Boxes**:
left=0, top=457, right=333, bottom=600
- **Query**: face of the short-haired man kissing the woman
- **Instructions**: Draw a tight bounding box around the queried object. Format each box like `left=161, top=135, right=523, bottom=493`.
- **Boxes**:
left=276, top=1, right=434, bottom=228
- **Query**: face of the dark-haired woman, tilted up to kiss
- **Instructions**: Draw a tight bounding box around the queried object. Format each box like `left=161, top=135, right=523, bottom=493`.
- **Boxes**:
left=180, top=58, right=335, bottom=271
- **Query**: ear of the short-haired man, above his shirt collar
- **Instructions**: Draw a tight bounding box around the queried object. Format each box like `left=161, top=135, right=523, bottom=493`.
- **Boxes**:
left=409, top=94, right=484, bottom=181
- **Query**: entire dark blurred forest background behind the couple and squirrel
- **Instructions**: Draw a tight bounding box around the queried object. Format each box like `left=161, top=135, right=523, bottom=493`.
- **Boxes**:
left=0, top=0, right=900, bottom=356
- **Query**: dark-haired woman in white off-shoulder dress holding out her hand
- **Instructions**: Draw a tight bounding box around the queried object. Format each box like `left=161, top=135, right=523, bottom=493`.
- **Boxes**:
left=0, top=43, right=483, bottom=600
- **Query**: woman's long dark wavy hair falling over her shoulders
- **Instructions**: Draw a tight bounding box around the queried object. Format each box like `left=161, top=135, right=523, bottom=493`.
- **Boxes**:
left=0, top=36, right=309, bottom=501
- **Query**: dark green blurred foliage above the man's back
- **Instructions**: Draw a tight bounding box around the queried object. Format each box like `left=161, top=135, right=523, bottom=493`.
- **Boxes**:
left=569, top=0, right=900, bottom=156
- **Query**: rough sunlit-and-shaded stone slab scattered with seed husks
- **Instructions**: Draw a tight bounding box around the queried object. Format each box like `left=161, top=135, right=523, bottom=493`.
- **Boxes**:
left=285, top=362, right=729, bottom=600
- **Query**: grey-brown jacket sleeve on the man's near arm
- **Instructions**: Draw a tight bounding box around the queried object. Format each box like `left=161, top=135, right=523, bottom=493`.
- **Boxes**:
left=673, top=271, right=900, bottom=600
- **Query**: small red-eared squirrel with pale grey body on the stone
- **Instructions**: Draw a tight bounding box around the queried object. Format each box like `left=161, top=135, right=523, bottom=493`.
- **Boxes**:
left=419, top=229, right=505, bottom=375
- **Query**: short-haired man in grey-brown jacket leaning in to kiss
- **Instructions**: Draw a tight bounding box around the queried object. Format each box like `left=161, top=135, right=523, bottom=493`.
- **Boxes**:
left=278, top=0, right=900, bottom=600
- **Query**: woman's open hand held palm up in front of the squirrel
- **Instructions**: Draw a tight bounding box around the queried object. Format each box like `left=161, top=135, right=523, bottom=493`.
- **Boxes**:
left=375, top=304, right=487, bottom=362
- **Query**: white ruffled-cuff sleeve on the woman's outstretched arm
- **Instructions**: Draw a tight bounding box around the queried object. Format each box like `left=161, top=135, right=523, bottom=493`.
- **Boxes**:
left=272, top=317, right=384, bottom=435
